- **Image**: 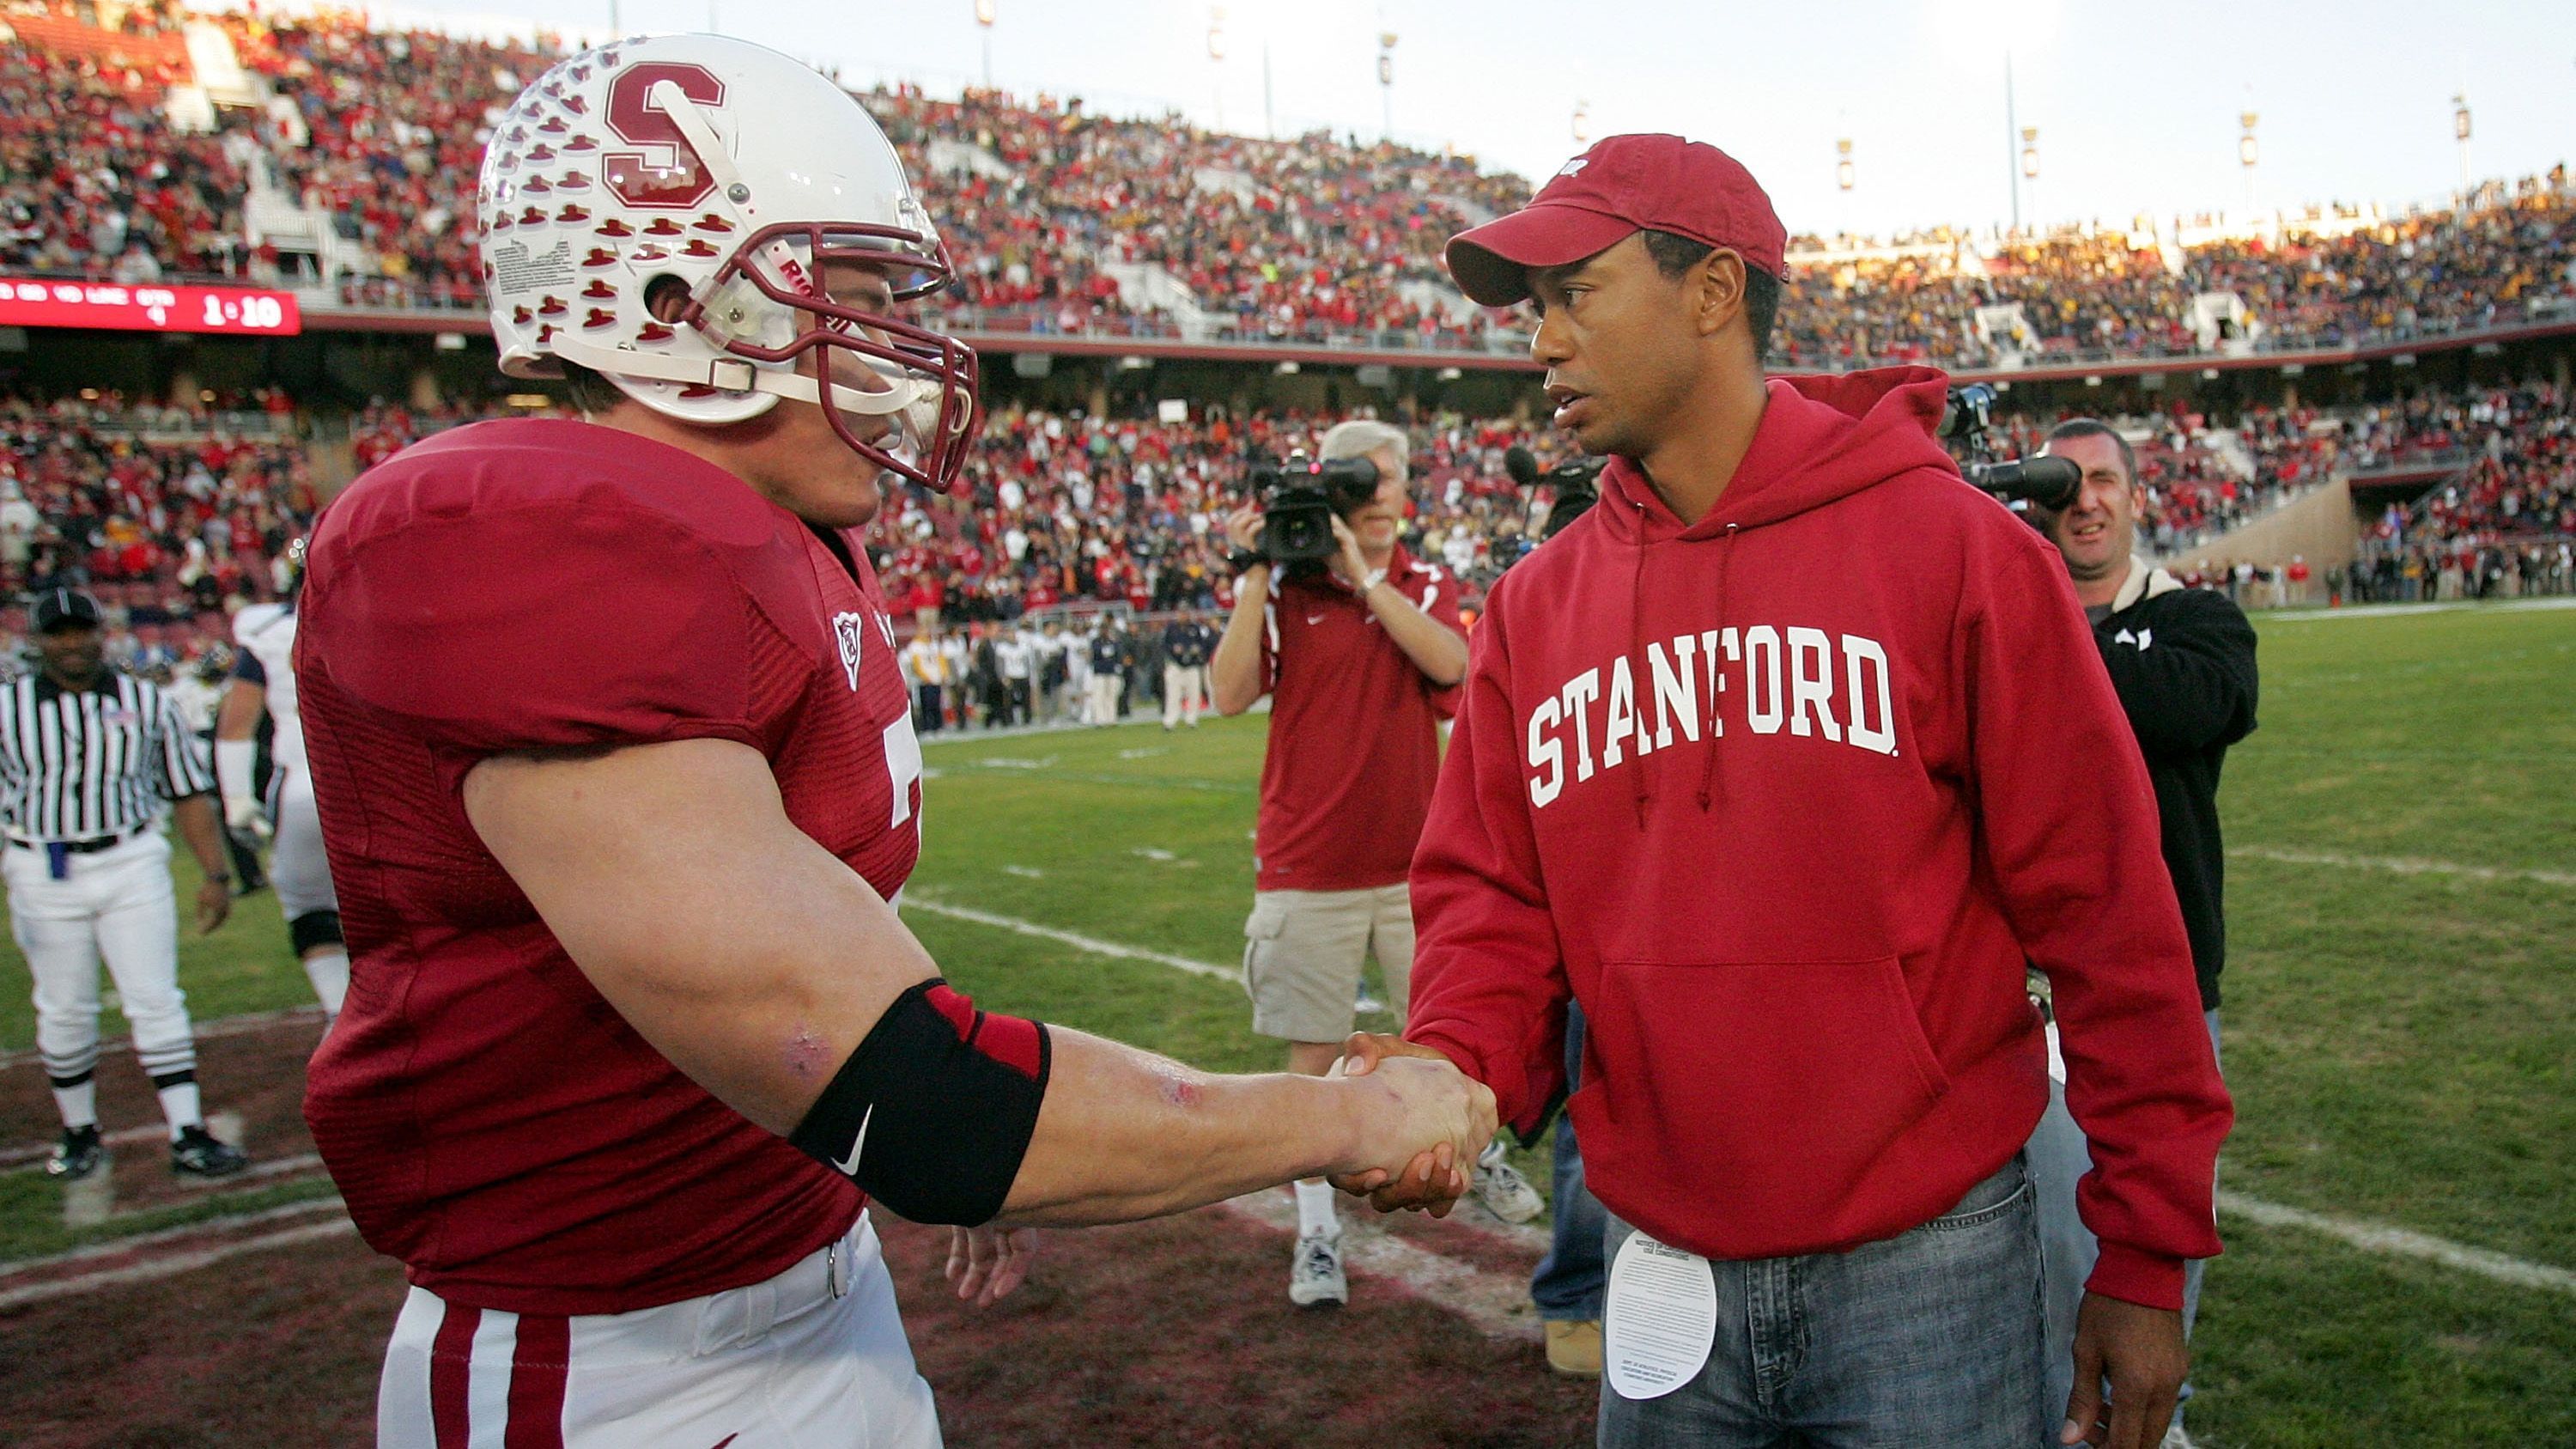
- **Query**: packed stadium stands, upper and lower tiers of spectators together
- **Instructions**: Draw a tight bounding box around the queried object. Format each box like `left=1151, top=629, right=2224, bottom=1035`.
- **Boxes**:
left=0, top=0, right=2576, bottom=670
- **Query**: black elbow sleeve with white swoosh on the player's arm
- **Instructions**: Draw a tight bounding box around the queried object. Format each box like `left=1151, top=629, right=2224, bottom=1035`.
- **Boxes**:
left=788, top=977, right=1051, bottom=1227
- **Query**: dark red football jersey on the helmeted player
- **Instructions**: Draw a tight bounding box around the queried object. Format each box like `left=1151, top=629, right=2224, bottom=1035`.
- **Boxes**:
left=296, top=420, right=922, bottom=1312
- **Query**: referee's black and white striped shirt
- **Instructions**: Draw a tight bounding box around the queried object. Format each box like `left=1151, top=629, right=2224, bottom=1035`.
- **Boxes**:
left=0, top=670, right=214, bottom=843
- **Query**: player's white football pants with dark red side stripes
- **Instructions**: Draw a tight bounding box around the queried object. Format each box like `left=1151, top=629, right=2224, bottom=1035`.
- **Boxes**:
left=376, top=1215, right=940, bottom=1449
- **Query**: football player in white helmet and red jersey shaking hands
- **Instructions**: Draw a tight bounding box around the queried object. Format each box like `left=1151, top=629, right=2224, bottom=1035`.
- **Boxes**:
left=296, top=36, right=1494, bottom=1449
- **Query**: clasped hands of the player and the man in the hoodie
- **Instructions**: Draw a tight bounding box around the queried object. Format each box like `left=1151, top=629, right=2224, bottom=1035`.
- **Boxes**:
left=1329, top=1032, right=1494, bottom=1217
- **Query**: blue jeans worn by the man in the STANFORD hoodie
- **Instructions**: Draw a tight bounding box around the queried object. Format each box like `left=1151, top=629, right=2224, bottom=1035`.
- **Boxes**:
left=1600, top=1158, right=2056, bottom=1449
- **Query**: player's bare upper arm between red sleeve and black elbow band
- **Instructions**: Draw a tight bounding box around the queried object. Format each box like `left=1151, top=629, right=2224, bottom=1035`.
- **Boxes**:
left=464, top=740, right=938, bottom=1135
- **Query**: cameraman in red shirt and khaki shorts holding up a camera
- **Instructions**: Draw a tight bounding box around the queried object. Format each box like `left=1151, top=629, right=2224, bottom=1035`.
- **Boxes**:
left=1208, top=420, right=1504, bottom=1307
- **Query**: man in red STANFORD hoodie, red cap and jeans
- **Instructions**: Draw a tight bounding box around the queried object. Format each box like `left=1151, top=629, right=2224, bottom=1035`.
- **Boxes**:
left=1350, top=137, right=2231, bottom=1449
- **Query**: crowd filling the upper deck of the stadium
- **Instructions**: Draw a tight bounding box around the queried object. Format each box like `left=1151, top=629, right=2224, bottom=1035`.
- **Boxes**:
left=0, top=0, right=2576, bottom=368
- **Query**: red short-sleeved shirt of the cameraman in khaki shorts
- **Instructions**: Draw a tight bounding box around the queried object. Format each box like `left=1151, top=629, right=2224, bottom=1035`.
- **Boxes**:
left=1252, top=544, right=1466, bottom=890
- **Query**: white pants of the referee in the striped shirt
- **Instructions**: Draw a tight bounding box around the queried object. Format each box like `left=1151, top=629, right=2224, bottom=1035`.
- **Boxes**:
left=0, top=831, right=196, bottom=1078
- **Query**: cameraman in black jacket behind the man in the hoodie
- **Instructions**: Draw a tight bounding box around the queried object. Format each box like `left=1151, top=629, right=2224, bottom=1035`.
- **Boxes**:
left=2030, top=417, right=2254, bottom=1444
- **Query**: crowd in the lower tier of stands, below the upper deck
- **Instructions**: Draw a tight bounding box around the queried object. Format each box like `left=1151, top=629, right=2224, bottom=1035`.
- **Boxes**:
left=0, top=371, right=2576, bottom=675
